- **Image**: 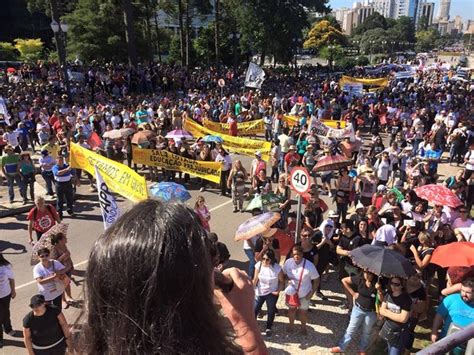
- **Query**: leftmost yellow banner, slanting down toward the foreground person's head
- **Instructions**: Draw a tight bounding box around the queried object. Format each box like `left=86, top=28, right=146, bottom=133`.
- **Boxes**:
left=70, top=143, right=148, bottom=202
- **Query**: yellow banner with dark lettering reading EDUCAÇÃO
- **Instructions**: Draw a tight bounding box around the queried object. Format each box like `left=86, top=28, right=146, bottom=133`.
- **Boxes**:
left=132, top=146, right=222, bottom=183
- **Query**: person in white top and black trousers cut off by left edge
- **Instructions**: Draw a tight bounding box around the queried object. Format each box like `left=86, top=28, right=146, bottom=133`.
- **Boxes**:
left=0, top=254, right=16, bottom=348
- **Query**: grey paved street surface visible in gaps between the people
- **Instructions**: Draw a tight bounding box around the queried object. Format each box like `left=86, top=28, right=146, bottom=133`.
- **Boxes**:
left=0, top=136, right=466, bottom=355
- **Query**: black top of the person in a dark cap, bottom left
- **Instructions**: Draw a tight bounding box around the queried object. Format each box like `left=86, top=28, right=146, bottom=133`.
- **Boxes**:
left=23, top=306, right=64, bottom=346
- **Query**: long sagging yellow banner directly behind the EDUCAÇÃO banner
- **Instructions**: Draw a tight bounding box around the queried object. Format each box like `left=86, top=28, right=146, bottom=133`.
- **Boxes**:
left=184, top=119, right=272, bottom=161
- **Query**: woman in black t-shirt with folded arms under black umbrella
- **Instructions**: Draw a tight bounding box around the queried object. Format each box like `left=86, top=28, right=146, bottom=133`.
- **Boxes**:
left=379, top=277, right=412, bottom=355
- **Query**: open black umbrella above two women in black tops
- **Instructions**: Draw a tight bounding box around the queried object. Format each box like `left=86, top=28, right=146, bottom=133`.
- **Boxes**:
left=349, top=245, right=416, bottom=278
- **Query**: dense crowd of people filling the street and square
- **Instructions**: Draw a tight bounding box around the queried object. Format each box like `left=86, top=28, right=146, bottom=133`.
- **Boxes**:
left=0, top=59, right=474, bottom=355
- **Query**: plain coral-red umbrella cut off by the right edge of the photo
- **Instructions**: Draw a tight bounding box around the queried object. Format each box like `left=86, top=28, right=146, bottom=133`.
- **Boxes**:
left=431, top=242, right=474, bottom=267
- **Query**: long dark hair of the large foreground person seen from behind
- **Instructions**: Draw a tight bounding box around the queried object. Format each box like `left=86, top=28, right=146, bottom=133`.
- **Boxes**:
left=78, top=200, right=242, bottom=354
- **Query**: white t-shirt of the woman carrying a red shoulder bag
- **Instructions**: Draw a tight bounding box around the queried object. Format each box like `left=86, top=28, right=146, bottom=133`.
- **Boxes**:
left=283, top=258, right=319, bottom=298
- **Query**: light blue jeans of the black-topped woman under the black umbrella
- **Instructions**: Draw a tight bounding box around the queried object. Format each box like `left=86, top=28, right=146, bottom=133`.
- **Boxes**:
left=339, top=305, right=377, bottom=351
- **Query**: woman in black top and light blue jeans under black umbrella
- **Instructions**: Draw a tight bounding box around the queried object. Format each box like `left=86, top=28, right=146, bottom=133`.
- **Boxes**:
left=329, top=270, right=383, bottom=355
